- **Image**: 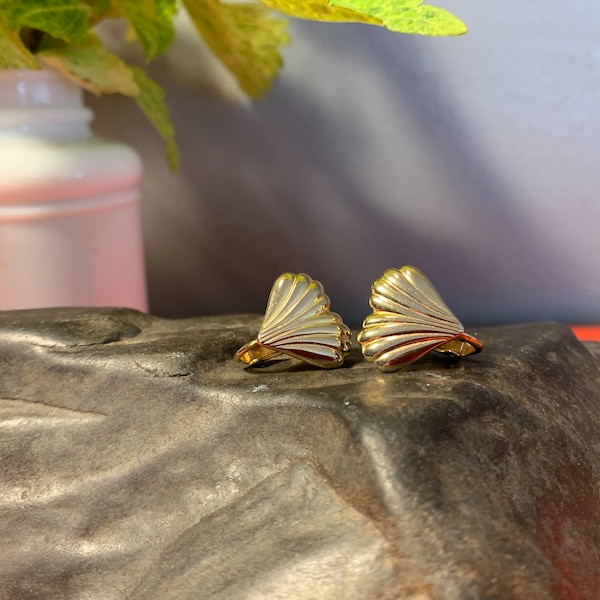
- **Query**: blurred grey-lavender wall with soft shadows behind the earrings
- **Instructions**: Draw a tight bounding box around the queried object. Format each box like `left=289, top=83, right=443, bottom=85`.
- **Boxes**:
left=90, top=0, right=600, bottom=325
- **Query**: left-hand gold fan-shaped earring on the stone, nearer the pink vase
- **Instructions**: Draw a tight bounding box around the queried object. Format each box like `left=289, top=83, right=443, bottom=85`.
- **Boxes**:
left=234, top=273, right=351, bottom=369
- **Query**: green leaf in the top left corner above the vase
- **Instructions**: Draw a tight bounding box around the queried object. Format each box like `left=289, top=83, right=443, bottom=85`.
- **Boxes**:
left=0, top=0, right=91, bottom=44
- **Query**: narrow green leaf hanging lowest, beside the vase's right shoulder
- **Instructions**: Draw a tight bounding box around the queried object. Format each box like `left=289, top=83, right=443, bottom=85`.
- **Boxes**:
left=129, top=66, right=179, bottom=171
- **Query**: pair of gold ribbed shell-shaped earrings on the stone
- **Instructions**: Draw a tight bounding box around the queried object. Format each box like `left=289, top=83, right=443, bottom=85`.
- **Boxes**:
left=235, top=266, right=483, bottom=371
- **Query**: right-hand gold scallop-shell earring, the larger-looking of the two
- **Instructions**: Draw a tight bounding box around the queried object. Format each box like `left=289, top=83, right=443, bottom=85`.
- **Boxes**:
left=358, top=266, right=483, bottom=371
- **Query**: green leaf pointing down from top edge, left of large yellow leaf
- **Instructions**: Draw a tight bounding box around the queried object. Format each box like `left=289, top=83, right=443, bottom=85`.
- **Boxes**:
left=116, top=0, right=177, bottom=62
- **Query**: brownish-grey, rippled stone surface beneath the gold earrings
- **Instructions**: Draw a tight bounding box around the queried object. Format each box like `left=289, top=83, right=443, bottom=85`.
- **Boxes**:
left=0, top=309, right=600, bottom=600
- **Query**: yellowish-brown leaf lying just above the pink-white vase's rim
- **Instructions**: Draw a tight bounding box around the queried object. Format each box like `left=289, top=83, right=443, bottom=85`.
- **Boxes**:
left=37, top=34, right=140, bottom=96
